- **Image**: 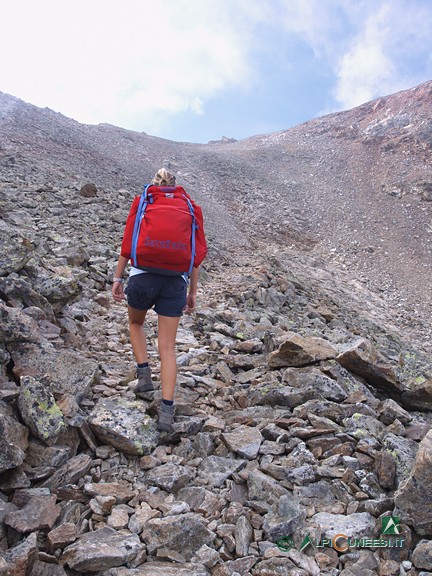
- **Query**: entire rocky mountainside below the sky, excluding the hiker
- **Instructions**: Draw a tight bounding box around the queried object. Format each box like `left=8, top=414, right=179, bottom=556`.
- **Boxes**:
left=0, top=83, right=432, bottom=576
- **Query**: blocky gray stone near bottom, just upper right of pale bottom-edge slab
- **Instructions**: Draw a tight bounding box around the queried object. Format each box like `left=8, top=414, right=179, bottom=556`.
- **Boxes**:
left=141, top=513, right=215, bottom=561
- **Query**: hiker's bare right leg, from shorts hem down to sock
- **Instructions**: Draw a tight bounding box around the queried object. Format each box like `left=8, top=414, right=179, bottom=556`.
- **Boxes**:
left=158, top=316, right=180, bottom=400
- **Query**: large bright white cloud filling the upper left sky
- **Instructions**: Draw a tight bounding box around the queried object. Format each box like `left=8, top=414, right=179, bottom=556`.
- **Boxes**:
left=0, top=0, right=262, bottom=132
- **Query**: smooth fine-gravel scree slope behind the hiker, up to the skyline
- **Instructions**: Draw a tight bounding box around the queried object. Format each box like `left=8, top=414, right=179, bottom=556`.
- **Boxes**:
left=0, top=82, right=432, bottom=349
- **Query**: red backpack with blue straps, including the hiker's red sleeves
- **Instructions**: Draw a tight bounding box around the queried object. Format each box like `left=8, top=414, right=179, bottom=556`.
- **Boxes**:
left=121, top=184, right=207, bottom=275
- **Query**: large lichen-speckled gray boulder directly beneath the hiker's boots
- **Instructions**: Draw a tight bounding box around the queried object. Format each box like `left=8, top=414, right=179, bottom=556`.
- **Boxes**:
left=88, top=397, right=159, bottom=456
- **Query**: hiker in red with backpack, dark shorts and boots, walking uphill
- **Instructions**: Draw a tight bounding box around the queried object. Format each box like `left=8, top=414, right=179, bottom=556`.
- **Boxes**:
left=112, top=168, right=207, bottom=432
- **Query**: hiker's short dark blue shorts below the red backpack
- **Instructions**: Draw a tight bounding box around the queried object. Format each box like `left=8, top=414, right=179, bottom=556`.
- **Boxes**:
left=126, top=272, right=187, bottom=317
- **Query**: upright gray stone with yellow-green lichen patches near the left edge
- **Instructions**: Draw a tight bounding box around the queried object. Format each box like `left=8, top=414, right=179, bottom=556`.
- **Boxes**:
left=18, top=376, right=66, bottom=444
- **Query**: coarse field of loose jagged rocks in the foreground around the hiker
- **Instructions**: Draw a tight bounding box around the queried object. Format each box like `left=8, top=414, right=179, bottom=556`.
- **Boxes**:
left=0, top=84, right=432, bottom=576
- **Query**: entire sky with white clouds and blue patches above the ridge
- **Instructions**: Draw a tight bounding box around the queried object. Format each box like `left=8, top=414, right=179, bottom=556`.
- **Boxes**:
left=0, top=0, right=432, bottom=142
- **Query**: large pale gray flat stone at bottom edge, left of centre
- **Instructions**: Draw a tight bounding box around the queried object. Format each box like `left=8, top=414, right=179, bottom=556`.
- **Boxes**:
left=60, top=527, right=143, bottom=572
